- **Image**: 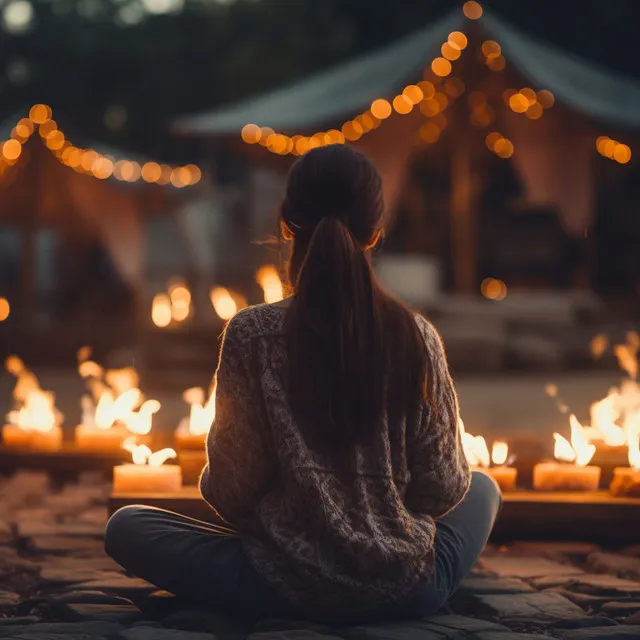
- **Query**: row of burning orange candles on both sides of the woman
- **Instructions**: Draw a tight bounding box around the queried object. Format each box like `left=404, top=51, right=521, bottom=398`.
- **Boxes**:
left=2, top=334, right=640, bottom=496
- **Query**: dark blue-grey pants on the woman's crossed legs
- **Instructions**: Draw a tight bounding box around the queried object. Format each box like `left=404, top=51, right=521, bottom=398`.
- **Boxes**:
left=105, top=472, right=502, bottom=619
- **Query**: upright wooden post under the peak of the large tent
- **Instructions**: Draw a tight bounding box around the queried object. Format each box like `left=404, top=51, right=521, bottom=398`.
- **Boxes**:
left=451, top=117, right=478, bottom=293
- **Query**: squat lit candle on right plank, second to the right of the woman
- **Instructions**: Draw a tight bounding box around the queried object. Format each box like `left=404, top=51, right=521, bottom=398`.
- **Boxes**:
left=533, top=415, right=601, bottom=491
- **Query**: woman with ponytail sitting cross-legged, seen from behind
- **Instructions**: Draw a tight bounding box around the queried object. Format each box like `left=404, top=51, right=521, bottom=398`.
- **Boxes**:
left=106, top=145, right=500, bottom=622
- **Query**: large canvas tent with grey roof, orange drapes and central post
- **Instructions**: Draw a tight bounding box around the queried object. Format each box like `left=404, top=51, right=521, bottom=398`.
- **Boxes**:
left=174, top=10, right=640, bottom=291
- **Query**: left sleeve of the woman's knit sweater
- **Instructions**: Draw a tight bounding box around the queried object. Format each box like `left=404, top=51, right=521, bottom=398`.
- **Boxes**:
left=200, top=318, right=274, bottom=530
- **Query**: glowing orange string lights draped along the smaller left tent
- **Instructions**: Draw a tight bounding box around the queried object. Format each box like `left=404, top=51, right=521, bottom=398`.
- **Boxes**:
left=0, top=104, right=202, bottom=187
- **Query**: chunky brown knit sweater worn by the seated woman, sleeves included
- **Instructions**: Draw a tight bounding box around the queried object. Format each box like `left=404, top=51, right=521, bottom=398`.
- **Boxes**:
left=201, top=304, right=470, bottom=619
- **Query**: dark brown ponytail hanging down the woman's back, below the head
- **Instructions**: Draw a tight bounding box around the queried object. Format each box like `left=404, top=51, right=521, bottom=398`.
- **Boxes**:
left=286, top=216, right=385, bottom=445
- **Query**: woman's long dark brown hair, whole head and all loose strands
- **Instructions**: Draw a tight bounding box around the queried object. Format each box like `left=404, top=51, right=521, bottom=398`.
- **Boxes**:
left=282, top=145, right=428, bottom=449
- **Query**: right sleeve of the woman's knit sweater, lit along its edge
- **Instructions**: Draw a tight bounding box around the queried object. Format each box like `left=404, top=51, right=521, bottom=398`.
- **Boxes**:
left=405, top=317, right=471, bottom=518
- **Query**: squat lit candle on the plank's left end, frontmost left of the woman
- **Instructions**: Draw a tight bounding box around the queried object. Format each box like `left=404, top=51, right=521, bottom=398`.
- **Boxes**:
left=113, top=443, right=182, bottom=494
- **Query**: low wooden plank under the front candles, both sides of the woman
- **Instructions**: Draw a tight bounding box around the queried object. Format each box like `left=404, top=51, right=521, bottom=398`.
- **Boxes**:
left=109, top=486, right=640, bottom=546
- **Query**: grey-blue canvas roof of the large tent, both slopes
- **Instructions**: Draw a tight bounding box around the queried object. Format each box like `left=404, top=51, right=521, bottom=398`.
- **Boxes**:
left=174, top=10, right=640, bottom=136
